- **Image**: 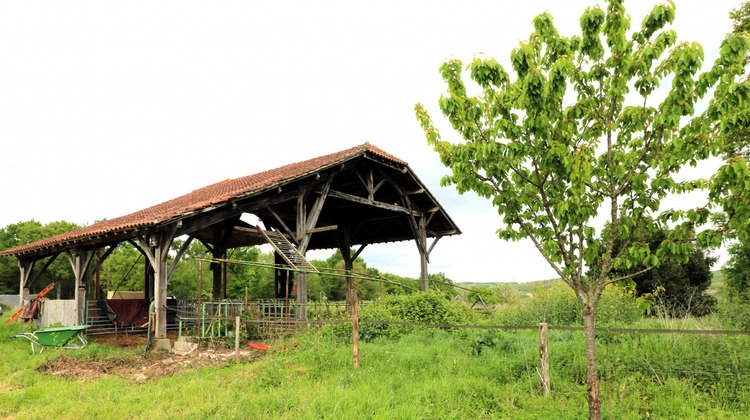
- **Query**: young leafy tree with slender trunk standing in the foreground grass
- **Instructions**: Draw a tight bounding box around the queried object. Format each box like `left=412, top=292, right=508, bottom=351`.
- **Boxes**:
left=415, top=0, right=750, bottom=419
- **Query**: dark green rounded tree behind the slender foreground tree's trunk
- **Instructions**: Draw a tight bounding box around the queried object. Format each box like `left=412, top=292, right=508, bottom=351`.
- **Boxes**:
left=604, top=229, right=718, bottom=316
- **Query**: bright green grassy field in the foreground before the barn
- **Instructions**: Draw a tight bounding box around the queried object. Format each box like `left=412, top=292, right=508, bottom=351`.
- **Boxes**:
left=0, top=304, right=750, bottom=419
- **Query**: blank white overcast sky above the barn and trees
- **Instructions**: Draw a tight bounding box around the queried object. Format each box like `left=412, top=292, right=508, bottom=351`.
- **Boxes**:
left=0, top=0, right=740, bottom=282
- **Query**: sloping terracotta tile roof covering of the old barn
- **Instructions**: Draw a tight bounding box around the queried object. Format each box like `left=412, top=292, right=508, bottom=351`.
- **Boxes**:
left=0, top=142, right=408, bottom=256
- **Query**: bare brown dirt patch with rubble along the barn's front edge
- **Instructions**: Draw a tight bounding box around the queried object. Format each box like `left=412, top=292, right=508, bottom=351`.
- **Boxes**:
left=37, top=334, right=261, bottom=383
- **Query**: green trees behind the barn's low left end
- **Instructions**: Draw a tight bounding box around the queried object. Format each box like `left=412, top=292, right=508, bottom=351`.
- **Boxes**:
left=0, top=220, right=80, bottom=298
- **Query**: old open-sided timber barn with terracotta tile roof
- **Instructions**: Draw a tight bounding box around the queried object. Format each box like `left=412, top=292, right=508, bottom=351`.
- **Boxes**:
left=0, top=143, right=460, bottom=338
